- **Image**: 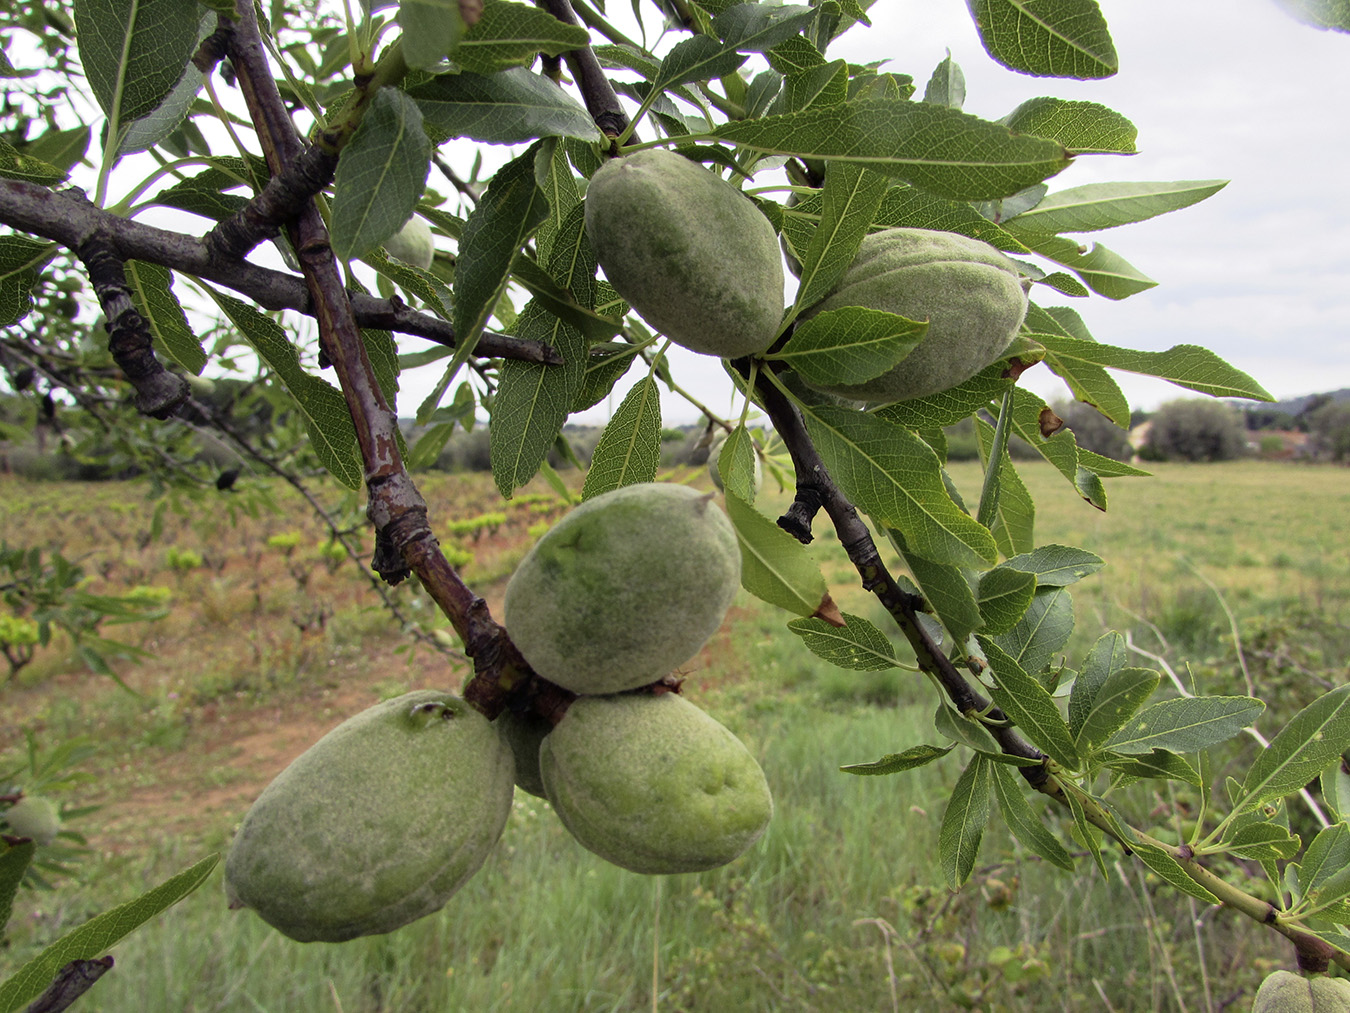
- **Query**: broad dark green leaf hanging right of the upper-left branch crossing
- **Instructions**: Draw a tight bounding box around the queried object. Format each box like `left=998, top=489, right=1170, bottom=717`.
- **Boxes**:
left=332, top=88, right=431, bottom=261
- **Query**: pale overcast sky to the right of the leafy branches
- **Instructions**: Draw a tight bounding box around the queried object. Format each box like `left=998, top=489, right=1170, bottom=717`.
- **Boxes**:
left=445, top=0, right=1350, bottom=424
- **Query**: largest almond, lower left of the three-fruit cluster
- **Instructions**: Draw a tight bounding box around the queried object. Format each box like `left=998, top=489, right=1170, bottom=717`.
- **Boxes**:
left=225, top=690, right=516, bottom=943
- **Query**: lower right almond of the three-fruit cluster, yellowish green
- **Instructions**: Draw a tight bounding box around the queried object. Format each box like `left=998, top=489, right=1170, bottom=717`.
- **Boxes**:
left=539, top=693, right=774, bottom=874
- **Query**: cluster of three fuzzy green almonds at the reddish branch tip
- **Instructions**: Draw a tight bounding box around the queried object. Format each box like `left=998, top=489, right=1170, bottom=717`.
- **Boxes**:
left=225, top=484, right=774, bottom=941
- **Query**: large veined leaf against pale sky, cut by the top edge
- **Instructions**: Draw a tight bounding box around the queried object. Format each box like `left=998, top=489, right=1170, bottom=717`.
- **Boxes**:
left=965, top=0, right=1119, bottom=80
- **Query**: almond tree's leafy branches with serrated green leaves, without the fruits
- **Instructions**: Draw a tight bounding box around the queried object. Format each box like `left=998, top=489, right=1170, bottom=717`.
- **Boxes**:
left=0, top=0, right=1350, bottom=1009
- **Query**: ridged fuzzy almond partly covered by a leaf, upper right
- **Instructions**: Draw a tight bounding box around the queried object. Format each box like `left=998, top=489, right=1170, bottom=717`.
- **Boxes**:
left=802, top=228, right=1027, bottom=402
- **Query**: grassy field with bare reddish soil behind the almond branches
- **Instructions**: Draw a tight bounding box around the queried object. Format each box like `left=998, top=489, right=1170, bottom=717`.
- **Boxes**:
left=0, top=463, right=1350, bottom=1013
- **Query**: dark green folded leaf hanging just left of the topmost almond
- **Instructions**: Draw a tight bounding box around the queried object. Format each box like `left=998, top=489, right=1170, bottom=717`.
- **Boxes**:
left=454, top=145, right=555, bottom=358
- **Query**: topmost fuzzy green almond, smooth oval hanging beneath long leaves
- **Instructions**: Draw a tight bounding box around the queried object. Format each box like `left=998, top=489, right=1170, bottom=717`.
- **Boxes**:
left=586, top=149, right=783, bottom=358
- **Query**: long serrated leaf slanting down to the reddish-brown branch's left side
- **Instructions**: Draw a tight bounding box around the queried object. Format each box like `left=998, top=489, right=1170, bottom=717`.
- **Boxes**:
left=203, top=285, right=365, bottom=489
